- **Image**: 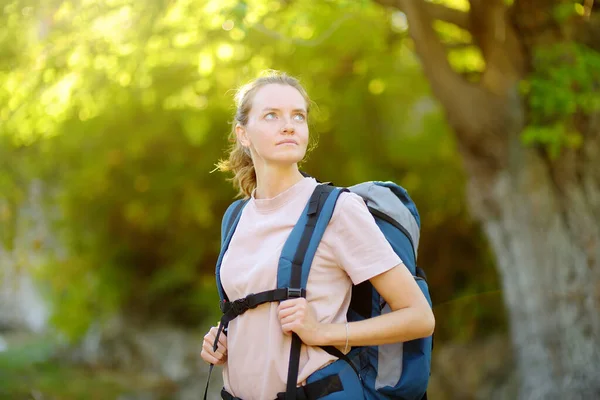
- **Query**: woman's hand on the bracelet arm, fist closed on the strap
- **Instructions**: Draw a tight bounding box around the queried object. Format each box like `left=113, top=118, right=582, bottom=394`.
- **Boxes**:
left=278, top=297, right=322, bottom=346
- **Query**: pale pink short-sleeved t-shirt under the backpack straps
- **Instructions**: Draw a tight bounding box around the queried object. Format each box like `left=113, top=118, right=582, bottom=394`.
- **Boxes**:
left=221, top=178, right=402, bottom=400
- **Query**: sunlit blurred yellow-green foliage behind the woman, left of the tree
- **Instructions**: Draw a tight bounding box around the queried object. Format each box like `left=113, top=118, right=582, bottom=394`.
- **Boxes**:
left=0, top=0, right=502, bottom=339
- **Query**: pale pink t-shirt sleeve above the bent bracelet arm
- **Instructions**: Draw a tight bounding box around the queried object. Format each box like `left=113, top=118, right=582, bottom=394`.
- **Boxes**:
left=331, top=193, right=402, bottom=285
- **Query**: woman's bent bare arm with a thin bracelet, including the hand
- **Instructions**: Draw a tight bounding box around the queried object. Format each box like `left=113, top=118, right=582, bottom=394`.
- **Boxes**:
left=279, top=264, right=435, bottom=347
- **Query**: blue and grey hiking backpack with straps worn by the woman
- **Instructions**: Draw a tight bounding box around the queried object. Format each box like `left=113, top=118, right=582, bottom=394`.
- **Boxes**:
left=205, top=182, right=433, bottom=400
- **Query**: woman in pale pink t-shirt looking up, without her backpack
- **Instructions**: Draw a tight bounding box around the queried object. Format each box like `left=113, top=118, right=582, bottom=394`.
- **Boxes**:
left=201, top=72, right=435, bottom=400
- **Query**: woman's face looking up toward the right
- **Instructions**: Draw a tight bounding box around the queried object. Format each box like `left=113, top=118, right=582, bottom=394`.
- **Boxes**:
left=236, top=84, right=308, bottom=166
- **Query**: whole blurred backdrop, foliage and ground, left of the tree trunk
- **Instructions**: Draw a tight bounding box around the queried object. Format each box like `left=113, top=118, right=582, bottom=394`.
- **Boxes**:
left=0, top=0, right=596, bottom=400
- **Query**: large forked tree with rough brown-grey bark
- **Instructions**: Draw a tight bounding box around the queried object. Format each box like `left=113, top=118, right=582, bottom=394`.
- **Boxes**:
left=376, top=0, right=600, bottom=400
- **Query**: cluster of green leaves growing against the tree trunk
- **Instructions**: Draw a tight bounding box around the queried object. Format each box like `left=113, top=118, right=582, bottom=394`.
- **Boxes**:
left=522, top=43, right=600, bottom=158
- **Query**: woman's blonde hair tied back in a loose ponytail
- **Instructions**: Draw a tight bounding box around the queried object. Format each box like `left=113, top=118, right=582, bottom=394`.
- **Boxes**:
left=216, top=70, right=316, bottom=198
